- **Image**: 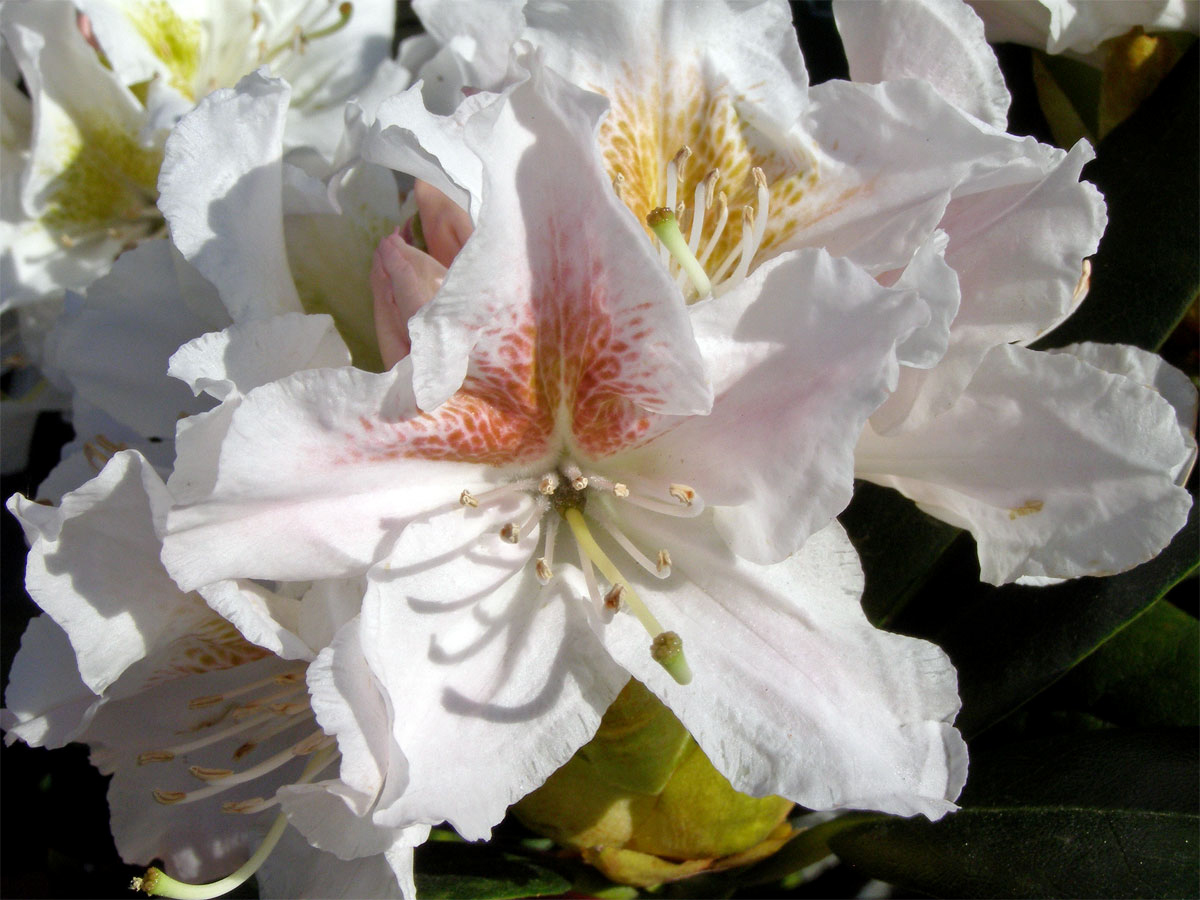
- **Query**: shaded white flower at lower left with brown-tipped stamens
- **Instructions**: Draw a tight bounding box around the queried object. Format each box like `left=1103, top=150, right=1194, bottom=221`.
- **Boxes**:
left=4, top=451, right=426, bottom=898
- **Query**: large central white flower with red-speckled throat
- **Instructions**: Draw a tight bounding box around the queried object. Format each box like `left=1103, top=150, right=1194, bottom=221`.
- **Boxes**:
left=163, top=52, right=966, bottom=868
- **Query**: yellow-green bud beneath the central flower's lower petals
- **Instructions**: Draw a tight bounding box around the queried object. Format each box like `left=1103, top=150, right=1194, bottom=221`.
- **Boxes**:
left=512, top=679, right=792, bottom=887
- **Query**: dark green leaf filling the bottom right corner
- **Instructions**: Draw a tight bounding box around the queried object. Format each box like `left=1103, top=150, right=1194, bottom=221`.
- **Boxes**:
left=829, top=730, right=1200, bottom=898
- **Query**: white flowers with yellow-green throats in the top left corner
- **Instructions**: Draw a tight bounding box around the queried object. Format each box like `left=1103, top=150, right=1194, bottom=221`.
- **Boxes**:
left=0, top=0, right=395, bottom=308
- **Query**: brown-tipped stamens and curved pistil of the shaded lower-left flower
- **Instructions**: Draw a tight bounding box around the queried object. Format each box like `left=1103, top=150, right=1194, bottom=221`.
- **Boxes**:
left=131, top=667, right=340, bottom=900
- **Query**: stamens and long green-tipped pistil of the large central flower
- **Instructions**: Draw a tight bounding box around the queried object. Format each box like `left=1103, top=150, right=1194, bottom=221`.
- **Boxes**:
left=458, top=462, right=703, bottom=684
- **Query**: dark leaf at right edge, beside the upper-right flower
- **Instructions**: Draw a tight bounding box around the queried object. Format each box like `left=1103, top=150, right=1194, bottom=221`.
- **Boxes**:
left=1036, top=46, right=1200, bottom=350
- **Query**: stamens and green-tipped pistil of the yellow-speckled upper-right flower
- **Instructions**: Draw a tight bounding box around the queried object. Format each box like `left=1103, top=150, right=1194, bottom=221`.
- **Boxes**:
left=613, top=146, right=770, bottom=302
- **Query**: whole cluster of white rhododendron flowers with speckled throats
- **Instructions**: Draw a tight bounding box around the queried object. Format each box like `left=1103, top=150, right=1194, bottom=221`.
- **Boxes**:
left=0, top=0, right=1196, bottom=898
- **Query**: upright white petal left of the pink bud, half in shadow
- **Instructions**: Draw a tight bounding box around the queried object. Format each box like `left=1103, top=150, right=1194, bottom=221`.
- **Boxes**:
left=158, top=72, right=300, bottom=322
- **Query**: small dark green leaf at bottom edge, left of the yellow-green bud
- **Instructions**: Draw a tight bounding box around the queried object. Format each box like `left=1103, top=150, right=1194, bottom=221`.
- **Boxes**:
left=415, top=842, right=571, bottom=900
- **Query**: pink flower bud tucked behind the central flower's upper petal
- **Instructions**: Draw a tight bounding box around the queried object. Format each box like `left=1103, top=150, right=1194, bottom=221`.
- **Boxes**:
left=371, top=228, right=446, bottom=368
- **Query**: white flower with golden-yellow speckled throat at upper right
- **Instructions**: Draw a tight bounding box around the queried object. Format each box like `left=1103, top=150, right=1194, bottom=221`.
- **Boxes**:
left=396, top=0, right=1190, bottom=582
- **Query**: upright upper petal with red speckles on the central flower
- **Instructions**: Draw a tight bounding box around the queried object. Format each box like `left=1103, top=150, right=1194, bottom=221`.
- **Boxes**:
left=409, top=47, right=712, bottom=422
